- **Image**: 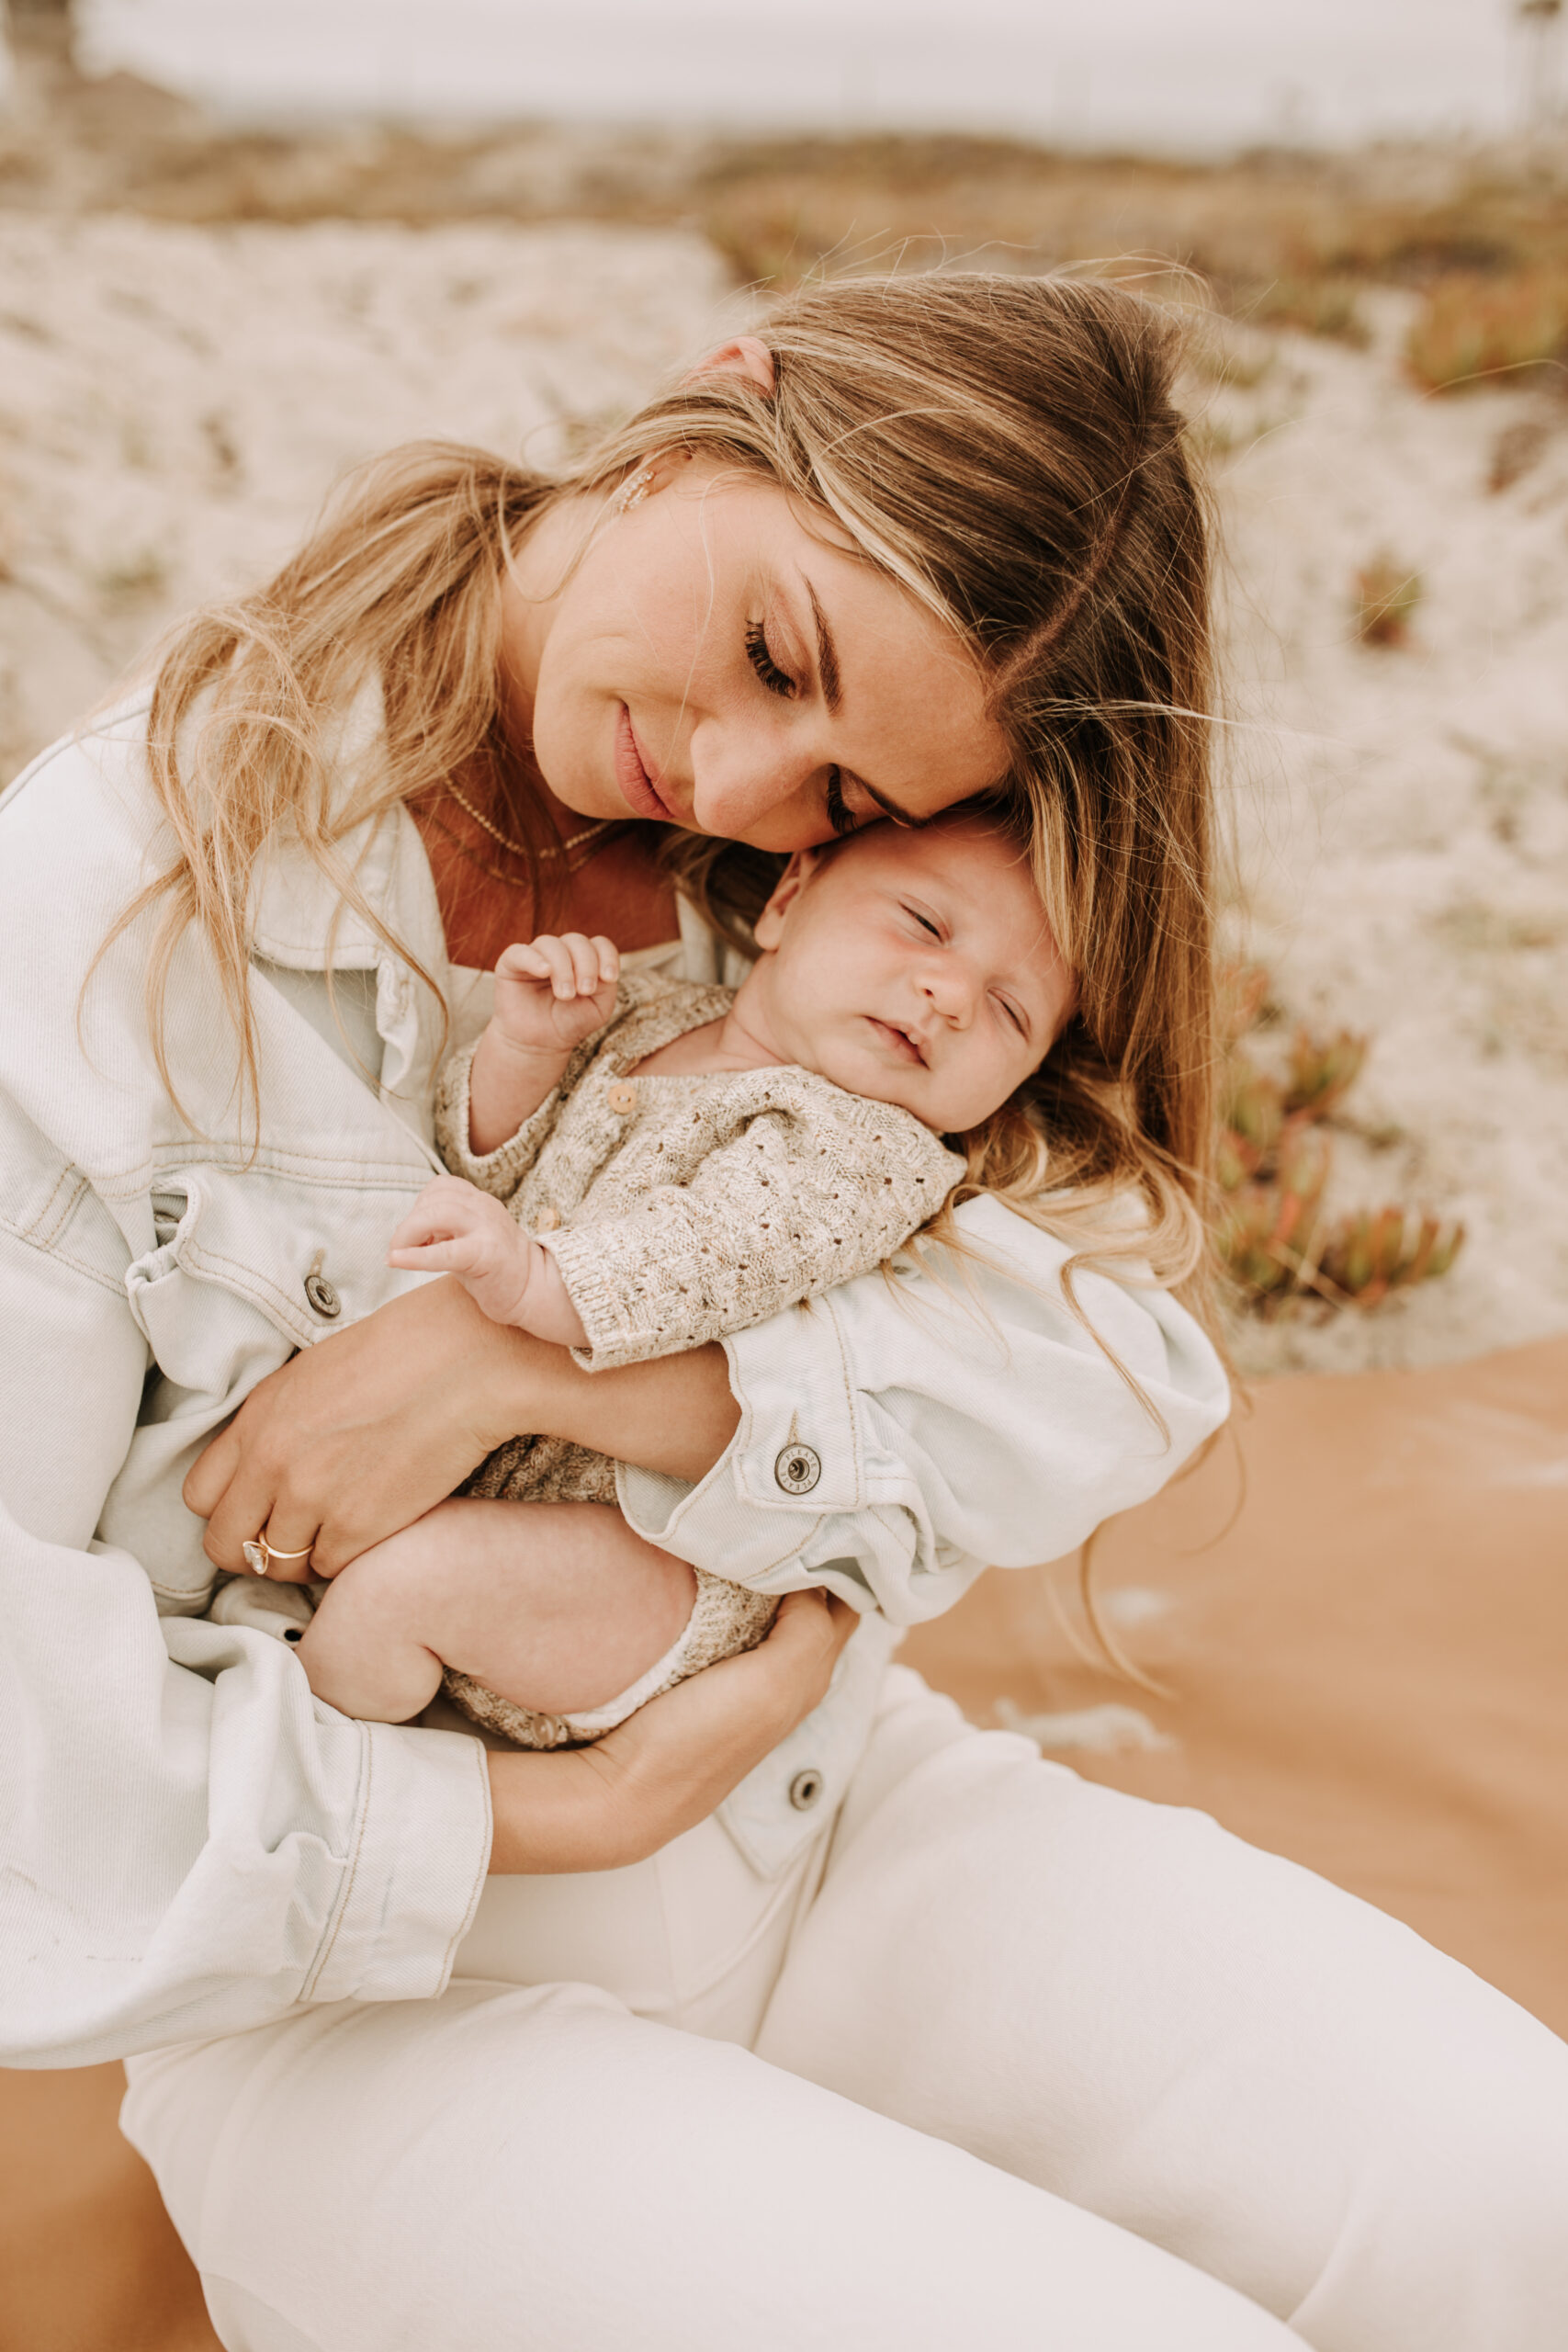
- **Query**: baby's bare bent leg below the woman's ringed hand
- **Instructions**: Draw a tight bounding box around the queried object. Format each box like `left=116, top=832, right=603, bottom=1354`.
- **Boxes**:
left=299, top=1496, right=696, bottom=1724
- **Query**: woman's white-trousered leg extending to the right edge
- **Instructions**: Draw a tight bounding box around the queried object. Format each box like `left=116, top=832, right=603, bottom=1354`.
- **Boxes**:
left=757, top=1668, right=1568, bottom=2352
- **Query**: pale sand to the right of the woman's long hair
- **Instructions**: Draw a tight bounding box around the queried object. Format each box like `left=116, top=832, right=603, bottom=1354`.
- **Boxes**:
left=1206, top=291, right=1568, bottom=1369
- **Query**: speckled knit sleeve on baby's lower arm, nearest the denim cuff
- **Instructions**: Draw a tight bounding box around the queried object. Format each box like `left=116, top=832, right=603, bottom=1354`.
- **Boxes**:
left=546, top=1087, right=964, bottom=1371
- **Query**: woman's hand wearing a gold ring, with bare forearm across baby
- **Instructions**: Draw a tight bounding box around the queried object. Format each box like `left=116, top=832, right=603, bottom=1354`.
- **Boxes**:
left=186, top=1280, right=740, bottom=1583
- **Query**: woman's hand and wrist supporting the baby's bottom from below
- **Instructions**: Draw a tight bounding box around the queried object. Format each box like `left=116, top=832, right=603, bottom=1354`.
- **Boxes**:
left=489, top=1592, right=858, bottom=1874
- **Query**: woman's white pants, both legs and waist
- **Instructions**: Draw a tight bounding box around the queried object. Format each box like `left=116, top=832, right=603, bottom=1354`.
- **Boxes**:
left=125, top=1668, right=1568, bottom=2352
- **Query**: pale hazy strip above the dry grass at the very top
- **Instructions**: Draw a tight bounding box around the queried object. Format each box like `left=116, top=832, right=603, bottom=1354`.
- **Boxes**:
left=77, top=0, right=1514, bottom=153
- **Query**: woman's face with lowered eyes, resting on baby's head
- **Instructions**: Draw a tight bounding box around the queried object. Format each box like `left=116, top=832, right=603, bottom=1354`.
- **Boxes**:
left=505, top=458, right=1009, bottom=849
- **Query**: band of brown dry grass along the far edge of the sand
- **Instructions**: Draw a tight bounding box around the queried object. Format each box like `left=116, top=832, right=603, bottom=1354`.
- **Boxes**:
left=0, top=63, right=1568, bottom=357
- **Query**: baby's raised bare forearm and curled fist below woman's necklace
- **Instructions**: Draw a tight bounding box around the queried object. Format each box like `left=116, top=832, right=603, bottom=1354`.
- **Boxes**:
left=468, top=932, right=621, bottom=1155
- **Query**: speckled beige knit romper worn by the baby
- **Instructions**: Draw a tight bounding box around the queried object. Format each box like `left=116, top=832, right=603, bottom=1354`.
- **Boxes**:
left=434, top=974, right=964, bottom=1747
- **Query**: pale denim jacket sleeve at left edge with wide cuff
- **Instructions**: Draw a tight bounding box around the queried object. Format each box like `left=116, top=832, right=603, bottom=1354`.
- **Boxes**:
left=0, top=1176, right=489, bottom=2065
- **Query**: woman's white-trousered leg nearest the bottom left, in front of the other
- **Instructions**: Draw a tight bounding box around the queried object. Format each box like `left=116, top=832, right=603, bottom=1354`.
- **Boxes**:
left=125, top=1983, right=1288, bottom=2352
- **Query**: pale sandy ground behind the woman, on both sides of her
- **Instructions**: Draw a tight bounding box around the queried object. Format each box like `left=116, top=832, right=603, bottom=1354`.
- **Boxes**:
left=0, top=211, right=1568, bottom=1371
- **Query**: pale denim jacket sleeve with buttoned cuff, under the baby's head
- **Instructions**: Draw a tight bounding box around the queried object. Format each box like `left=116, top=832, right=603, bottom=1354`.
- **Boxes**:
left=621, top=1200, right=1229, bottom=1625
